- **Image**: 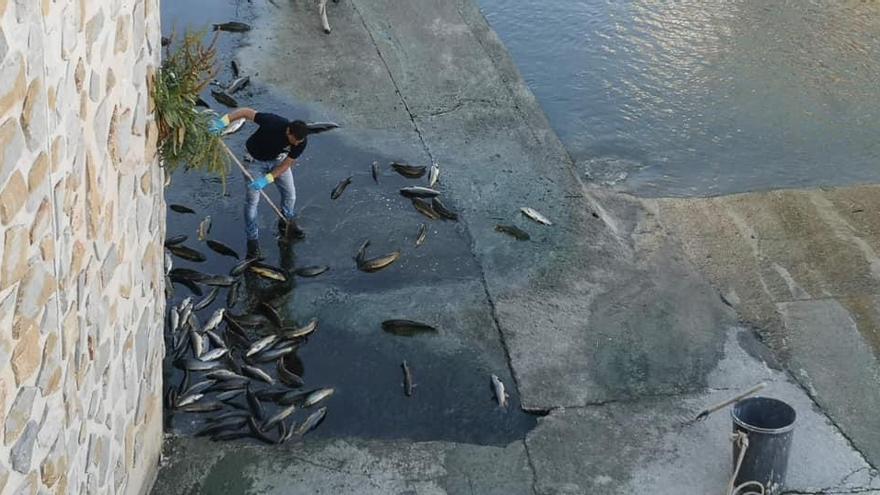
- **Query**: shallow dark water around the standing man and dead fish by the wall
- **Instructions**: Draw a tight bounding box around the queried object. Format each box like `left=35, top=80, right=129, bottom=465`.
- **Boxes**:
left=162, top=0, right=535, bottom=444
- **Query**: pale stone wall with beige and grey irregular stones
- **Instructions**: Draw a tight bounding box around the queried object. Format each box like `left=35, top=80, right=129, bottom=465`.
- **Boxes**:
left=0, top=0, right=165, bottom=494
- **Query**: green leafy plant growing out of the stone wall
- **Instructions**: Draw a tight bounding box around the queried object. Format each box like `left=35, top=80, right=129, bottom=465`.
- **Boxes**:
left=152, top=33, right=229, bottom=186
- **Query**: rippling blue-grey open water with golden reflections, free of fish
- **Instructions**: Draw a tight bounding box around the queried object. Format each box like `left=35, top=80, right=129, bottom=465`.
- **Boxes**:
left=479, top=0, right=880, bottom=196
